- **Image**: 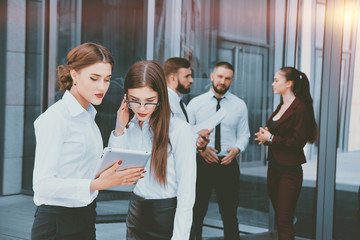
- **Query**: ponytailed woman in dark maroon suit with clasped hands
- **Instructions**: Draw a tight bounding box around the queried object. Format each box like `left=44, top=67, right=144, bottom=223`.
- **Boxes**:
left=255, top=67, right=318, bottom=240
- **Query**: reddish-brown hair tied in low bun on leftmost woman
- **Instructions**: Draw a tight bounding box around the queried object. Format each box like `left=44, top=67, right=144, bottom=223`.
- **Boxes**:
left=57, top=42, right=114, bottom=92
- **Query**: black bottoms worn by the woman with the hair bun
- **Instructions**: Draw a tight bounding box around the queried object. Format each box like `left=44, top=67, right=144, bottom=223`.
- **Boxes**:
left=31, top=200, right=96, bottom=240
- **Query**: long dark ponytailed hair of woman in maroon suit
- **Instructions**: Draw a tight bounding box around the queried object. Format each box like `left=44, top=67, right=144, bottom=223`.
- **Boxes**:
left=280, top=67, right=319, bottom=143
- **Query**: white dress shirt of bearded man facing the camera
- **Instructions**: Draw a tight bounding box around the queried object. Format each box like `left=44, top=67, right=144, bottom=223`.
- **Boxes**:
left=187, top=89, right=250, bottom=156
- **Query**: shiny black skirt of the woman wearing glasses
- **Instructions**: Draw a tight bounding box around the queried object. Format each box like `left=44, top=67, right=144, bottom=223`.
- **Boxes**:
left=126, top=194, right=177, bottom=240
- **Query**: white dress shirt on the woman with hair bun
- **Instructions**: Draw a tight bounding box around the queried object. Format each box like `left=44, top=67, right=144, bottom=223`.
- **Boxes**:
left=33, top=91, right=103, bottom=207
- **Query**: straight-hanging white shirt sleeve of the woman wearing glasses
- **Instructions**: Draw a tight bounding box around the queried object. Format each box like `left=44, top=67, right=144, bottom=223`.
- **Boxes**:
left=171, top=124, right=196, bottom=240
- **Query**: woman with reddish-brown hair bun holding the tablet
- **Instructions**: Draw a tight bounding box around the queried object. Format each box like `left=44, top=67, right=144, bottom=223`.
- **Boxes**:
left=31, top=43, right=144, bottom=240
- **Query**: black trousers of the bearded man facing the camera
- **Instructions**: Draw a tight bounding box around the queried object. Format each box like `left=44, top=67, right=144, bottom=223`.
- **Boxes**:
left=190, top=154, right=240, bottom=240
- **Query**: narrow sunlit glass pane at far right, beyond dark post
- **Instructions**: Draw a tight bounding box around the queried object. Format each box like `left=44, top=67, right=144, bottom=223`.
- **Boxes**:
left=334, top=0, right=360, bottom=240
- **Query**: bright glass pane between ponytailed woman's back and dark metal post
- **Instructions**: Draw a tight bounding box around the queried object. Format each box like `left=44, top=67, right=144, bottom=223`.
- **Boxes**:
left=294, top=1, right=326, bottom=239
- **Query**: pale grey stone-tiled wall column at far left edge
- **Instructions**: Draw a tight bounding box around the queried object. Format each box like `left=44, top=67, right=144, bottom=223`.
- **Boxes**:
left=1, top=0, right=26, bottom=195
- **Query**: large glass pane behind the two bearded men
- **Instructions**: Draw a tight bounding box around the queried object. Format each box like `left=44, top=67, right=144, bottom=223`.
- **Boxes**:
left=179, top=0, right=274, bottom=233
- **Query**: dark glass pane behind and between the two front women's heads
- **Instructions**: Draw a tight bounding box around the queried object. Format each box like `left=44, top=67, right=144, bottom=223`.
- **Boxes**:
left=82, top=0, right=147, bottom=146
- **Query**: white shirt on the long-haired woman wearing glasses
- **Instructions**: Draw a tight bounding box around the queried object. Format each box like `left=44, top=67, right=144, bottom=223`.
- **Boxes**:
left=109, top=116, right=196, bottom=240
